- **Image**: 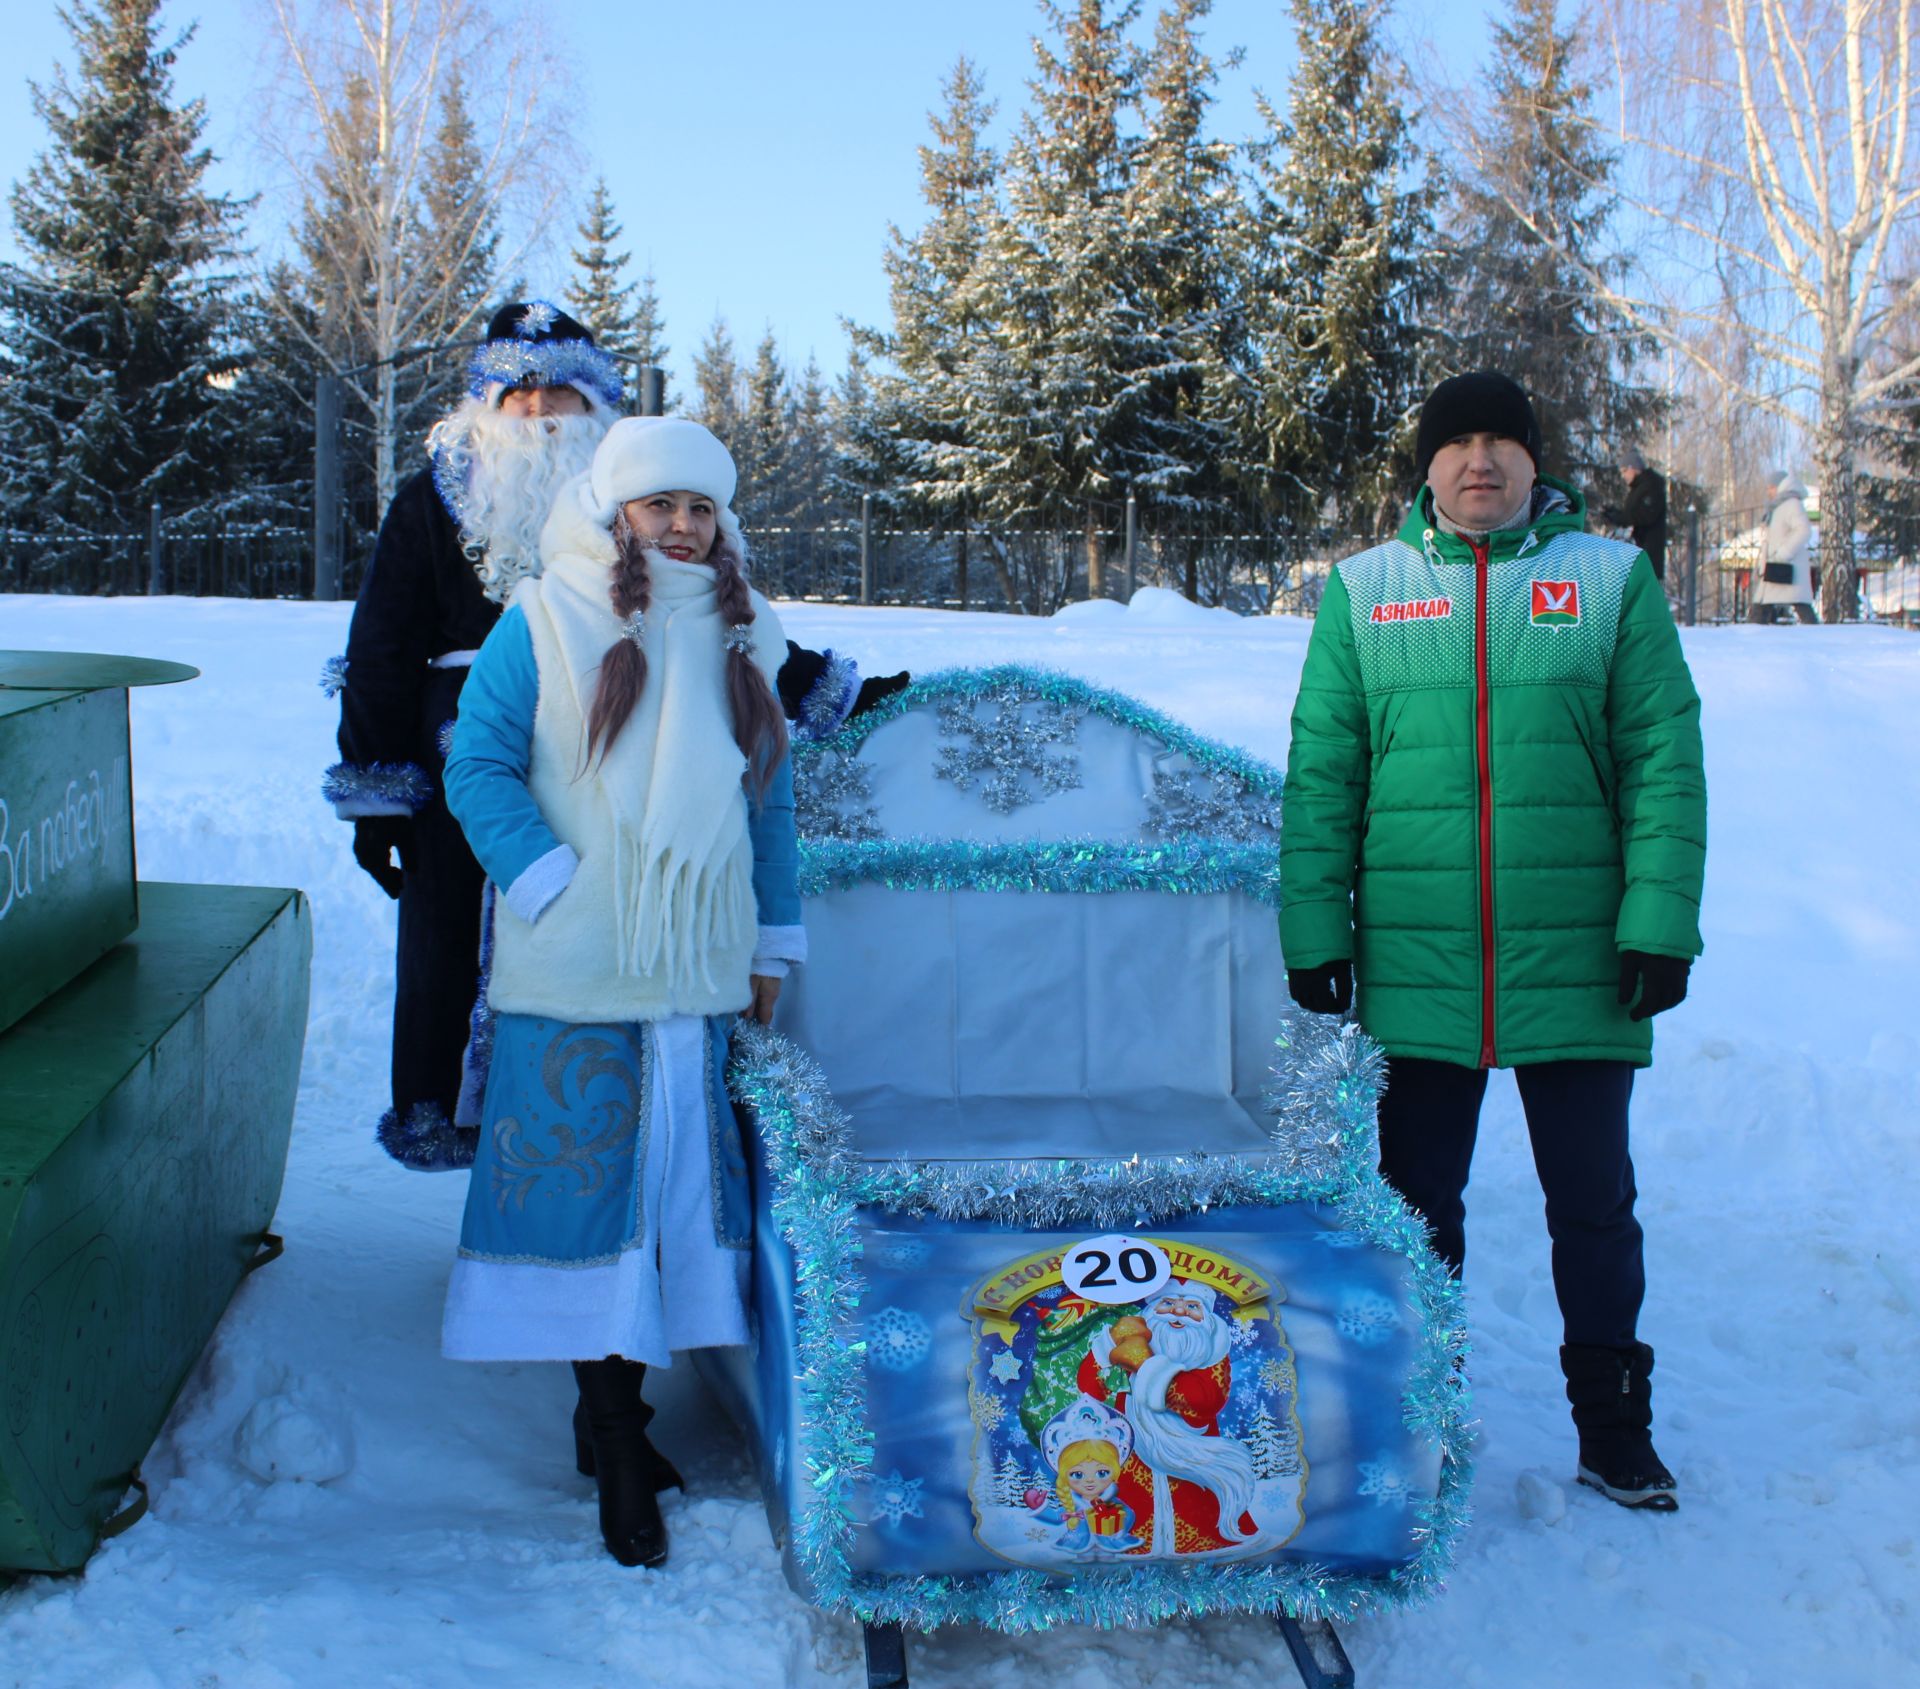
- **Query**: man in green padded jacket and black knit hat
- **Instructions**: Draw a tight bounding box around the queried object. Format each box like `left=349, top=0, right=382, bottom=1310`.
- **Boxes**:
left=1281, top=370, right=1707, bottom=1511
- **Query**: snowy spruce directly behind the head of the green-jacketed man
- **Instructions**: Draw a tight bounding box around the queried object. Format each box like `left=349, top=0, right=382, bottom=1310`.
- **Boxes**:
left=1434, top=0, right=1665, bottom=495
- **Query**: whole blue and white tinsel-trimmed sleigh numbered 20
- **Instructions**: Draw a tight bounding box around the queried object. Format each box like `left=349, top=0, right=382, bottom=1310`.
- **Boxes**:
left=710, top=668, right=1469, bottom=1683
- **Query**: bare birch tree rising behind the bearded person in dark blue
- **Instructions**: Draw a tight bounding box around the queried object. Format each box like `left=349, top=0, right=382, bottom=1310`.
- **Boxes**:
left=271, top=0, right=570, bottom=509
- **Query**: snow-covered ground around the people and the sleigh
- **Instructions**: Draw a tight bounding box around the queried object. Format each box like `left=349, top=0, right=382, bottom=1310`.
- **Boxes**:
left=0, top=597, right=1920, bottom=1689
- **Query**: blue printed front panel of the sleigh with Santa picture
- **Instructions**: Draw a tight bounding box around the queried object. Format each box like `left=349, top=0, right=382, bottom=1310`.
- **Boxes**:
left=849, top=1203, right=1440, bottom=1576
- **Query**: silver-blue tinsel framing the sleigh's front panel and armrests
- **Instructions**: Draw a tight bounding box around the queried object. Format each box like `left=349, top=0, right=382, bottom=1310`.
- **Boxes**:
left=728, top=1015, right=1471, bottom=1631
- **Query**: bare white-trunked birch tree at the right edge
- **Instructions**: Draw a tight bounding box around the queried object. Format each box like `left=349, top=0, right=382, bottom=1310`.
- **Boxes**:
left=1543, top=0, right=1920, bottom=620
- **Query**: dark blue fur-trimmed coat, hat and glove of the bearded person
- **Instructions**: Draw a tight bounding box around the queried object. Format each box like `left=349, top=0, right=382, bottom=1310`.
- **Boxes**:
left=323, top=299, right=890, bottom=1171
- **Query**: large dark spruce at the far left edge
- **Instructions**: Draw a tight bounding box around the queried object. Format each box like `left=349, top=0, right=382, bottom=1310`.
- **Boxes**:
left=0, top=0, right=242, bottom=580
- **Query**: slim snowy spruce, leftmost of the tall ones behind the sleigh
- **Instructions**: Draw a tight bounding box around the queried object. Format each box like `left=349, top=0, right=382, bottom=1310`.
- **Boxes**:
left=854, top=56, right=1000, bottom=607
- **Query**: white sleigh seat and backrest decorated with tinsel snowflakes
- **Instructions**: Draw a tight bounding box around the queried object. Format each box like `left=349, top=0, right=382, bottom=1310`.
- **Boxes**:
left=780, top=670, right=1284, bottom=1159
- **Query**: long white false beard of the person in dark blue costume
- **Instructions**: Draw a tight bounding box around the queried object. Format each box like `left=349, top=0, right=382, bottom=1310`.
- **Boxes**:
left=426, top=399, right=611, bottom=605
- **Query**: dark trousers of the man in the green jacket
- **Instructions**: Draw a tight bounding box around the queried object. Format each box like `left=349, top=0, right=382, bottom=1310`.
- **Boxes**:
left=1380, top=1056, right=1647, bottom=1349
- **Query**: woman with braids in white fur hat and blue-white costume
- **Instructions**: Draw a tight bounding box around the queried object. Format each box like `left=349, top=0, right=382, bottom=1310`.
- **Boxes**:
left=442, top=416, right=804, bottom=1566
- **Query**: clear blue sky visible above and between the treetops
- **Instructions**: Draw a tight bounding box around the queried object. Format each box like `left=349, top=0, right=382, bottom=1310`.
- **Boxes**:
left=0, top=0, right=1486, bottom=384
